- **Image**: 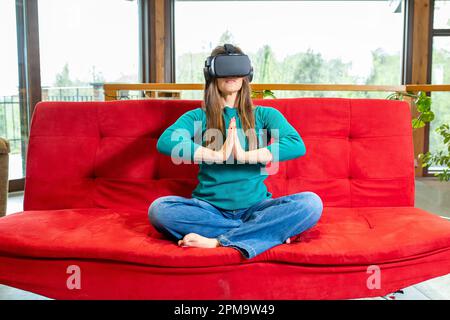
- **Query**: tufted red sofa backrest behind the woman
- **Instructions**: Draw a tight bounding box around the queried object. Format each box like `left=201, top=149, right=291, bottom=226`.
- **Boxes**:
left=24, top=98, right=414, bottom=211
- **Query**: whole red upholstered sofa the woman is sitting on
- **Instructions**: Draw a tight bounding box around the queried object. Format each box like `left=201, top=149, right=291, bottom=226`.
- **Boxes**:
left=0, top=98, right=450, bottom=299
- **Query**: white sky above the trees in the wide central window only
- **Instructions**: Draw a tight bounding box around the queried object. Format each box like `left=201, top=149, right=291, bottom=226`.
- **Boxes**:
left=175, top=1, right=403, bottom=73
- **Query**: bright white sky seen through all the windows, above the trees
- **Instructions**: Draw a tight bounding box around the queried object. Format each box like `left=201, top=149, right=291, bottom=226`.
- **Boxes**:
left=0, top=0, right=450, bottom=96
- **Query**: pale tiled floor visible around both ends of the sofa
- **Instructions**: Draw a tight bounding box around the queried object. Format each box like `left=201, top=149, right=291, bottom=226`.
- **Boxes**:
left=0, top=178, right=450, bottom=300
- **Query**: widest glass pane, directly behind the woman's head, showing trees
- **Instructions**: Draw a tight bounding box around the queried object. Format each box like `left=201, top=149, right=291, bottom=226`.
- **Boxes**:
left=175, top=0, right=404, bottom=99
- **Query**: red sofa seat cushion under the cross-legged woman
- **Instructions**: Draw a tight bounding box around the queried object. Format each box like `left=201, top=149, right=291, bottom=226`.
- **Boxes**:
left=0, top=207, right=450, bottom=267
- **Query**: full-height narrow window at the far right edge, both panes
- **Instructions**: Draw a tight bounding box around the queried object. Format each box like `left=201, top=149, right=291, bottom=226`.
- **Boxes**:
left=429, top=0, right=450, bottom=171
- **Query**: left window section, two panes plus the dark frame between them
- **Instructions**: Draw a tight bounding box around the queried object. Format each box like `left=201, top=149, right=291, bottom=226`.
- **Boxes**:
left=0, top=0, right=139, bottom=180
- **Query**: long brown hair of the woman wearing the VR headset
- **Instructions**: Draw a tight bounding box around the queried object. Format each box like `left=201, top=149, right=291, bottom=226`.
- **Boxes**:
left=202, top=46, right=258, bottom=150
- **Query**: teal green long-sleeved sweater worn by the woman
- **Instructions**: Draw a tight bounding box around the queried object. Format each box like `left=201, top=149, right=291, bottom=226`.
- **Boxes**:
left=156, top=106, right=306, bottom=210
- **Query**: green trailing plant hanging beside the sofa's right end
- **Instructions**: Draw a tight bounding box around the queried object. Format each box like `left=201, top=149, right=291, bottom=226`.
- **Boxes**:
left=386, top=91, right=450, bottom=181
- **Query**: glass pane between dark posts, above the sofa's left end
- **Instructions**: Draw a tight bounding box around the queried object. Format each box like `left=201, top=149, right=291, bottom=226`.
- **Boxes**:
left=38, top=0, right=139, bottom=101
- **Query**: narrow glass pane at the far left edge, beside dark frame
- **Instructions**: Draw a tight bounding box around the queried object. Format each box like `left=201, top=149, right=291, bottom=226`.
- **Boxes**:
left=0, top=0, right=23, bottom=180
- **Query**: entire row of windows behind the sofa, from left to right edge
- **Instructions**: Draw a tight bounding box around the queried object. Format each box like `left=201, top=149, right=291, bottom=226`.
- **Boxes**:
left=0, top=0, right=450, bottom=185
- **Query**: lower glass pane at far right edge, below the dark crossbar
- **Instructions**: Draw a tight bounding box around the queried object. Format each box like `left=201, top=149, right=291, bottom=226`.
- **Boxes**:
left=429, top=37, right=450, bottom=170
